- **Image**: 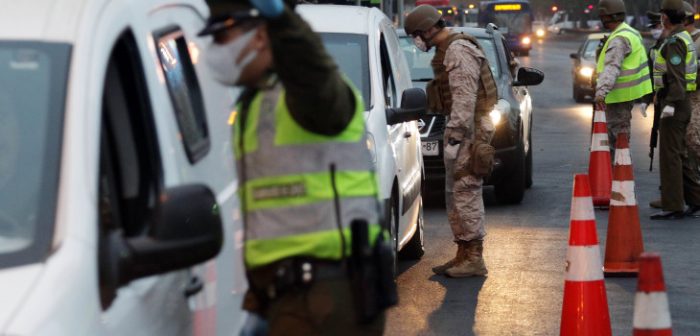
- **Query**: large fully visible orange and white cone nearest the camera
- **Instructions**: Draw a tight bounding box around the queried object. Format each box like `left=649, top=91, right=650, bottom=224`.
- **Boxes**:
left=560, top=174, right=612, bottom=336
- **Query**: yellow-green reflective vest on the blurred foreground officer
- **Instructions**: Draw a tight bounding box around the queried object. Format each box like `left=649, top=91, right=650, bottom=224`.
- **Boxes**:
left=234, top=85, right=381, bottom=268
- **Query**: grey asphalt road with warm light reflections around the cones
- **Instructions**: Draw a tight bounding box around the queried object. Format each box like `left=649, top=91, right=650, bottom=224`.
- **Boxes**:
left=386, top=37, right=700, bottom=335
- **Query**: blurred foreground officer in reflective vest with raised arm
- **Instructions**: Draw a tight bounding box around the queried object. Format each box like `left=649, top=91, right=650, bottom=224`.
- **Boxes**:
left=200, top=0, right=395, bottom=335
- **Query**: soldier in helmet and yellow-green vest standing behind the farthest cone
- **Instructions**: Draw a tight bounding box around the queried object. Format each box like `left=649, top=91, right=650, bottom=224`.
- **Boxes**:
left=594, top=0, right=652, bottom=149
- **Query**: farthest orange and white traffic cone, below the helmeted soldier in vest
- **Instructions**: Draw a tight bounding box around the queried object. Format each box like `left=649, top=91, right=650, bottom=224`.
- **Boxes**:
left=588, top=111, right=612, bottom=207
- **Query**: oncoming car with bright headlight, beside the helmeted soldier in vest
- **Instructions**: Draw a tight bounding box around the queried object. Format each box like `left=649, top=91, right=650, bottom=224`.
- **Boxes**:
left=571, top=34, right=605, bottom=103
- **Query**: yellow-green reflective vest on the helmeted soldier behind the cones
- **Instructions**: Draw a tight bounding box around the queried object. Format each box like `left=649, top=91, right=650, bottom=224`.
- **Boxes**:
left=597, top=23, right=652, bottom=104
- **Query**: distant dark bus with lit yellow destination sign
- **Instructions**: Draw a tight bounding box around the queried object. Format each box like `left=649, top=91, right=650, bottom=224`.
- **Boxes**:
left=479, top=0, right=532, bottom=56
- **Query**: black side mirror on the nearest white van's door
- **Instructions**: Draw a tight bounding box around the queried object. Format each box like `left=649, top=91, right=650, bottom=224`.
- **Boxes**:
left=102, top=185, right=223, bottom=288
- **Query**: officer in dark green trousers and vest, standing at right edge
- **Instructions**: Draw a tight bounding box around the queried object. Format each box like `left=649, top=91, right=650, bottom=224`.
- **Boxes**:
left=651, top=0, right=700, bottom=219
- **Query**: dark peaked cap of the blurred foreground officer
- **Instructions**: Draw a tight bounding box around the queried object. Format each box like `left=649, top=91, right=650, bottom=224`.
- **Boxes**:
left=198, top=0, right=262, bottom=36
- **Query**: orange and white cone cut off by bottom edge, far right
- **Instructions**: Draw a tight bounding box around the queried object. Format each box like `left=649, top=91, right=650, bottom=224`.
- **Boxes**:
left=633, top=253, right=672, bottom=336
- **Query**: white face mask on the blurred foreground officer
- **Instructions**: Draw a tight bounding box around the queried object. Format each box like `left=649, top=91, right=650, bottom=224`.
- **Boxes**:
left=205, top=29, right=258, bottom=86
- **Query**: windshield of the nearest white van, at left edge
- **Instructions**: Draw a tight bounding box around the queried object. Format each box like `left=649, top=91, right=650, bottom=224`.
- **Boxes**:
left=0, top=41, right=70, bottom=268
